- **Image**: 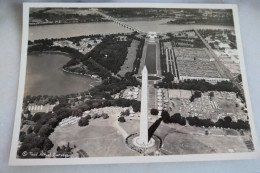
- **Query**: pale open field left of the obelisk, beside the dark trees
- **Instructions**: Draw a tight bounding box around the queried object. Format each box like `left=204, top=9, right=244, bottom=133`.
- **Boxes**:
left=50, top=117, right=138, bottom=157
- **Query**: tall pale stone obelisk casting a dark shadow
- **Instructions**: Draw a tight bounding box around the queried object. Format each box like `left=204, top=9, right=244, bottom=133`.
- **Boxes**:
left=138, top=66, right=149, bottom=145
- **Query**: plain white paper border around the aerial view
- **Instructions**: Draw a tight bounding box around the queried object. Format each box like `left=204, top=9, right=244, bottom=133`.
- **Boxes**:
left=9, top=3, right=260, bottom=166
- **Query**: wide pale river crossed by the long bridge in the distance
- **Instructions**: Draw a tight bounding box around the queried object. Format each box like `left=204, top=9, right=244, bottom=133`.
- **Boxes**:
left=29, top=19, right=233, bottom=41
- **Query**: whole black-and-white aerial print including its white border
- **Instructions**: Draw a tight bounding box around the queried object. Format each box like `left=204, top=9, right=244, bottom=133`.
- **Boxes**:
left=10, top=3, right=258, bottom=165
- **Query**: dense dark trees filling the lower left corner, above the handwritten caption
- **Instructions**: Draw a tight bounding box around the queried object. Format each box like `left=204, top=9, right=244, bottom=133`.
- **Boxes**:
left=17, top=101, right=72, bottom=157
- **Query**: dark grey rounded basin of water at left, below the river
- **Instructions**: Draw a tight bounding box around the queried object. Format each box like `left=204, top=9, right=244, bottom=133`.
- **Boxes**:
left=24, top=53, right=99, bottom=96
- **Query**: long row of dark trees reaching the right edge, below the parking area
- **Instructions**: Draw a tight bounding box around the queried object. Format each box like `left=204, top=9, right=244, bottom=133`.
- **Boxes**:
left=186, top=116, right=250, bottom=130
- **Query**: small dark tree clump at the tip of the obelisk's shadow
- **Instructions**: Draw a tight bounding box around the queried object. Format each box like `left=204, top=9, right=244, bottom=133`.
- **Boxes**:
left=161, top=110, right=186, bottom=126
